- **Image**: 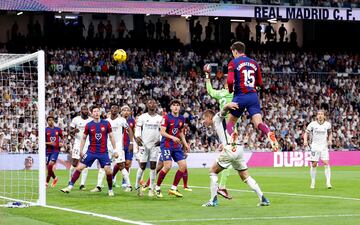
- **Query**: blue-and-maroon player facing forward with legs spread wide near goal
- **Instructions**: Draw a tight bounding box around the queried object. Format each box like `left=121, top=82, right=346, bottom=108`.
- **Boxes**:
left=61, top=106, right=119, bottom=196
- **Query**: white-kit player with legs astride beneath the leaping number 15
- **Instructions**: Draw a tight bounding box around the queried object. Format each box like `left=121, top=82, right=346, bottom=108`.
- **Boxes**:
left=202, top=102, right=270, bottom=207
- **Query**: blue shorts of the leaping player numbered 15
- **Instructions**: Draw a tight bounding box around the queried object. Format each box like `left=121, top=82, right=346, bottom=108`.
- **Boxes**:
left=230, top=92, right=261, bottom=118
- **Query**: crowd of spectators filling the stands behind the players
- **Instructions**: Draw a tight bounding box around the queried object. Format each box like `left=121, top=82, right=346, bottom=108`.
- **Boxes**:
left=0, top=49, right=360, bottom=152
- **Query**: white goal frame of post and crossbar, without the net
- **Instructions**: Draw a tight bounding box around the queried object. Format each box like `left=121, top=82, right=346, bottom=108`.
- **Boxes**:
left=0, top=50, right=46, bottom=206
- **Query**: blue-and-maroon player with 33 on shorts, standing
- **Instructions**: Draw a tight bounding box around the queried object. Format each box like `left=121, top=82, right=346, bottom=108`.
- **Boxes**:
left=155, top=99, right=190, bottom=198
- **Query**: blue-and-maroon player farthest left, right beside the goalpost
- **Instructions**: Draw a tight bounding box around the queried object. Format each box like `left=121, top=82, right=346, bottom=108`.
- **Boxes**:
left=45, top=116, right=63, bottom=187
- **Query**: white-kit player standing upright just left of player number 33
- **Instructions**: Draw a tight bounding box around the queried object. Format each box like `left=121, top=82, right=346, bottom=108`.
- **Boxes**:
left=135, top=99, right=162, bottom=197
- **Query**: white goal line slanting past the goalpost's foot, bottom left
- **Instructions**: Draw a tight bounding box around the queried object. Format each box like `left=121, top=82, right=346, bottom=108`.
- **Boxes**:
left=0, top=196, right=152, bottom=225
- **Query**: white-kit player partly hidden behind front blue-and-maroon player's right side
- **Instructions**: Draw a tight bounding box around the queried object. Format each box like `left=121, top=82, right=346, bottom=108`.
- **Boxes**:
left=91, top=104, right=133, bottom=192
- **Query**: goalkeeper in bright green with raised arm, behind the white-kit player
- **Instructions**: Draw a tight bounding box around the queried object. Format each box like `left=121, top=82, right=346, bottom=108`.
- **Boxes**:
left=204, top=64, right=234, bottom=199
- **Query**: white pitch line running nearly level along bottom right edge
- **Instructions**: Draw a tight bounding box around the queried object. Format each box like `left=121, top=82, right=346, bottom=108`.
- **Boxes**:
left=146, top=214, right=360, bottom=223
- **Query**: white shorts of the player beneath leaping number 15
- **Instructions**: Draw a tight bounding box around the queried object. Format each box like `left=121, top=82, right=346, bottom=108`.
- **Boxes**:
left=216, top=146, right=248, bottom=171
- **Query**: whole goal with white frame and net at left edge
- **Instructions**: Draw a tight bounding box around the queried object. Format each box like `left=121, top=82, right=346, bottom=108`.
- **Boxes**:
left=0, top=51, right=46, bottom=206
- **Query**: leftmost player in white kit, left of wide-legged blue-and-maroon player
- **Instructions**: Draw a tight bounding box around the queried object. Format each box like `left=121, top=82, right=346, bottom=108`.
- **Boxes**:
left=69, top=105, right=92, bottom=191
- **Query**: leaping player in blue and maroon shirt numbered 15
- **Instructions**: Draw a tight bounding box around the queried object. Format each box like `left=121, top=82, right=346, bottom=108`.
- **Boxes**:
left=226, top=42, right=279, bottom=151
